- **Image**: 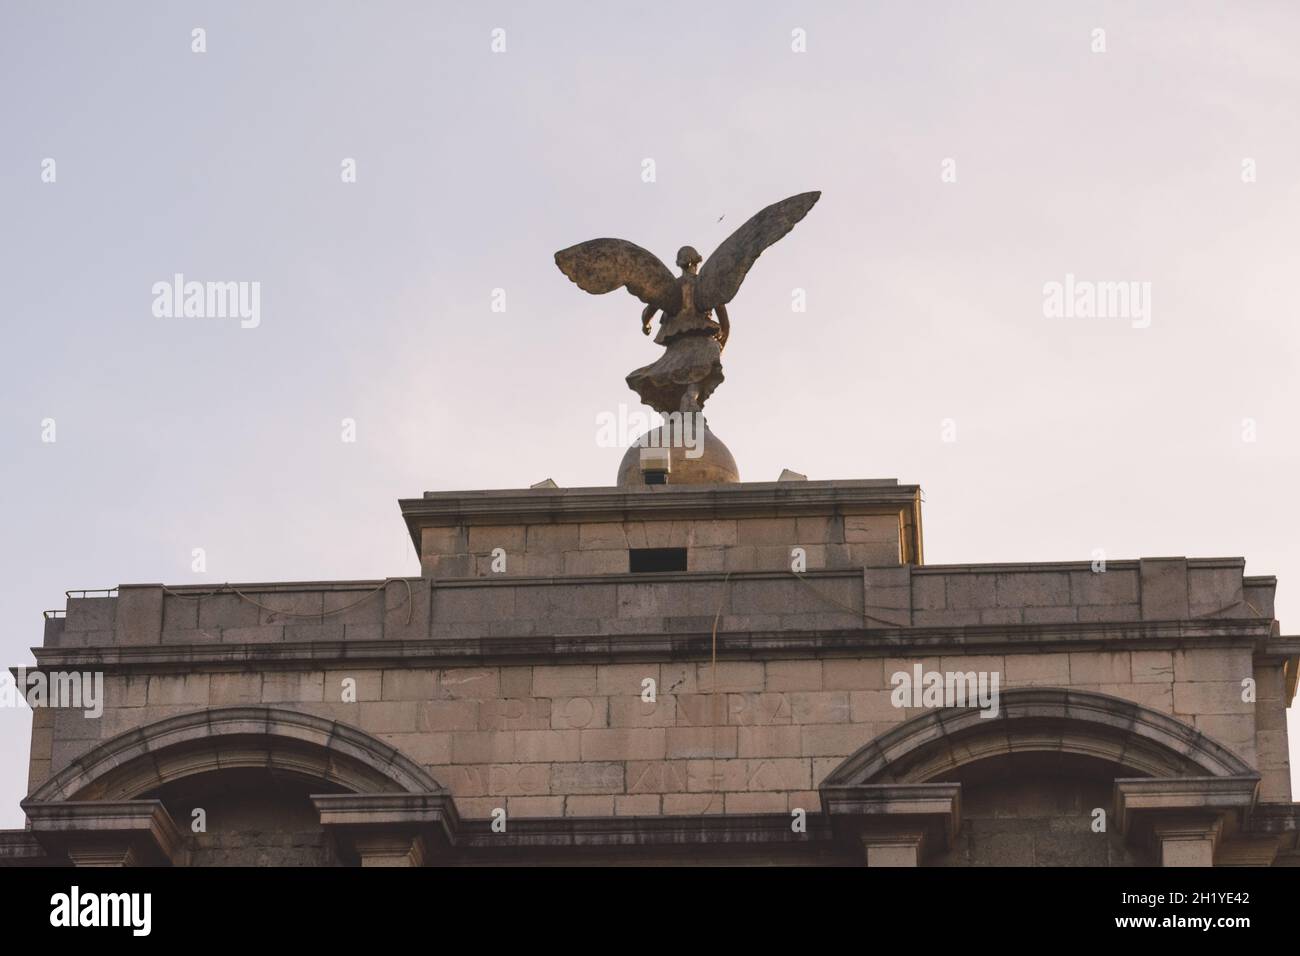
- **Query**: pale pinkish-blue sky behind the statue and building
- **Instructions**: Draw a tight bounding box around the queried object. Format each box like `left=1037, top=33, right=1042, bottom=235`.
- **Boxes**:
left=0, top=0, right=1300, bottom=826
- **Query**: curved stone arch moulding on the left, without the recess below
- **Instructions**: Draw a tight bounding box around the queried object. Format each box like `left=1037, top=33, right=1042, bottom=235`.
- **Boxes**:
left=23, top=706, right=445, bottom=803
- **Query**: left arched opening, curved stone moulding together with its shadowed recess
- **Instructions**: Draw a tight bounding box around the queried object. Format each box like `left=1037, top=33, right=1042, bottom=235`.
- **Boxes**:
left=23, top=708, right=446, bottom=866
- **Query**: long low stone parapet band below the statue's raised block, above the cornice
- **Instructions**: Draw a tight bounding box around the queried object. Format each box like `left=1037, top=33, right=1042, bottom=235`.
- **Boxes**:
left=44, top=555, right=1277, bottom=648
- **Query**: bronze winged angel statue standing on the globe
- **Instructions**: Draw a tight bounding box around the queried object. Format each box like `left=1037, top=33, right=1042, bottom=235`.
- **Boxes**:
left=555, top=193, right=822, bottom=415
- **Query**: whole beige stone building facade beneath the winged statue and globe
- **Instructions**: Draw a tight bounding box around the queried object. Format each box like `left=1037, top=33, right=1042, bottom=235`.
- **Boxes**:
left=0, top=481, right=1300, bottom=866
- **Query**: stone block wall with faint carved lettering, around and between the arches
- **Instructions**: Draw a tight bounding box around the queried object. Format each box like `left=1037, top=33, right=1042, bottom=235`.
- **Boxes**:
left=30, top=634, right=1290, bottom=818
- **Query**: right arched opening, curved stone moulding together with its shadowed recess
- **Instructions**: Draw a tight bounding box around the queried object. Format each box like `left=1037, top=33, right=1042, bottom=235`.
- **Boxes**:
left=820, top=688, right=1258, bottom=866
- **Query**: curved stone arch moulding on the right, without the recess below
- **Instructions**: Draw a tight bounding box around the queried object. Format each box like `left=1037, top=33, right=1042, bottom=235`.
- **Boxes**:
left=820, top=687, right=1255, bottom=787
